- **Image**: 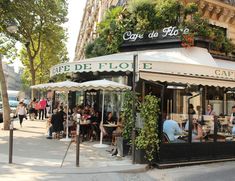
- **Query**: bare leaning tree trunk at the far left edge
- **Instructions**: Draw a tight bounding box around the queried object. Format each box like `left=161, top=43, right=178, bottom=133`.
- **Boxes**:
left=0, top=54, right=10, bottom=130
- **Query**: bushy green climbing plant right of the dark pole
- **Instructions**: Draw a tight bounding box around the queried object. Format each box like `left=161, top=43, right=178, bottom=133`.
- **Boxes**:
left=136, top=95, right=160, bottom=163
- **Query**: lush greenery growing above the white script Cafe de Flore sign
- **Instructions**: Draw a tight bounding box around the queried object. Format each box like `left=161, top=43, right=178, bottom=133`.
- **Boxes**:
left=85, top=0, right=234, bottom=58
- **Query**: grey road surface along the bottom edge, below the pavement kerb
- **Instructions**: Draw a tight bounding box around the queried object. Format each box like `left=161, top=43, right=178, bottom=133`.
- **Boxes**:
left=0, top=162, right=235, bottom=181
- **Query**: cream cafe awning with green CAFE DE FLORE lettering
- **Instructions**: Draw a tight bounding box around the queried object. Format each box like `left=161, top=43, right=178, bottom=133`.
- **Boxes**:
left=50, top=47, right=235, bottom=87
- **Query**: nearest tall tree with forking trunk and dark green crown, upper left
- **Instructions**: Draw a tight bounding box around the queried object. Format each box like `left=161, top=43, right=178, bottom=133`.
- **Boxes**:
left=0, top=0, right=67, bottom=97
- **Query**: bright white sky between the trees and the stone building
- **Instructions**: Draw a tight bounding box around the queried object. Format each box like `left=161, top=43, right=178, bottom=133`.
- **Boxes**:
left=13, top=0, right=86, bottom=71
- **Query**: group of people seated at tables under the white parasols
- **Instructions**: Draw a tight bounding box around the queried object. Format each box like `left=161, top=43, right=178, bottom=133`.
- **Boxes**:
left=48, top=105, right=121, bottom=144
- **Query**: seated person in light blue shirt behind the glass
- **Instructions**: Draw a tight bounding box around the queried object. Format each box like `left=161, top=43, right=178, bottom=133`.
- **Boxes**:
left=163, top=120, right=183, bottom=142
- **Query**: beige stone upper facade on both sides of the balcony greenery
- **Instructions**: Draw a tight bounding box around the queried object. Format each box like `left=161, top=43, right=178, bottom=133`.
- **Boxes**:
left=75, top=0, right=235, bottom=60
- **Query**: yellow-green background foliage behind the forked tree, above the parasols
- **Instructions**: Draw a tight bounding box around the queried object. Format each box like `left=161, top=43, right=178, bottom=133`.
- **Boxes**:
left=20, top=25, right=68, bottom=85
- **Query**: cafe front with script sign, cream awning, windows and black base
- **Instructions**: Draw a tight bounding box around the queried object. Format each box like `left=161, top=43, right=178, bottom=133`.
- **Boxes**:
left=50, top=27, right=235, bottom=164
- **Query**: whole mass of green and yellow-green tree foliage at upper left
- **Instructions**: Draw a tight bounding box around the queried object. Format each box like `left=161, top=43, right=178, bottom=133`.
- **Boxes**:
left=0, top=0, right=67, bottom=97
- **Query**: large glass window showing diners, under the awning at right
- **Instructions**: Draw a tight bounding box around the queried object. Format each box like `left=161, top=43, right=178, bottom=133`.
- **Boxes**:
left=149, top=84, right=235, bottom=143
